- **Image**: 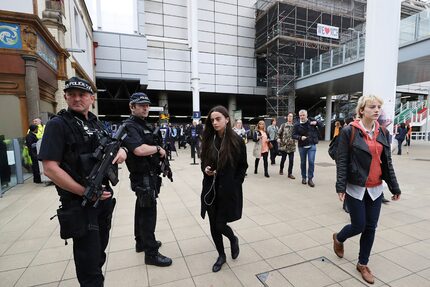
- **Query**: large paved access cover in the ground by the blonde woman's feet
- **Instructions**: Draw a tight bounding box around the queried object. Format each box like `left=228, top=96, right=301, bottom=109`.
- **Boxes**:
left=256, top=257, right=367, bottom=287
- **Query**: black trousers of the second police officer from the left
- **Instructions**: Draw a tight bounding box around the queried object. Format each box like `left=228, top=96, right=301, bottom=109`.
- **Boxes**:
left=134, top=199, right=158, bottom=256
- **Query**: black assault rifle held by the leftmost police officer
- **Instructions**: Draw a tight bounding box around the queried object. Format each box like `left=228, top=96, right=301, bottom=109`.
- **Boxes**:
left=82, top=125, right=127, bottom=207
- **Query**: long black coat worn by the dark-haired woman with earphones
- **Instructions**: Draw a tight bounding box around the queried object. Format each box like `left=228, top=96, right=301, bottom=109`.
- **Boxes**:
left=200, top=140, right=248, bottom=222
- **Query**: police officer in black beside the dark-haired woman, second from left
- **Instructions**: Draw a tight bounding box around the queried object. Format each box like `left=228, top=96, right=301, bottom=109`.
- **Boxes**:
left=123, top=93, right=172, bottom=267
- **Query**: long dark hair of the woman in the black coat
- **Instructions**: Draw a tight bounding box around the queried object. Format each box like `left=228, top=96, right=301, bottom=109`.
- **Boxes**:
left=201, top=106, right=241, bottom=170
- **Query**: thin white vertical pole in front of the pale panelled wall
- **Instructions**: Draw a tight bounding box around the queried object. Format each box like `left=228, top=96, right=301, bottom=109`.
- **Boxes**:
left=188, top=0, right=201, bottom=120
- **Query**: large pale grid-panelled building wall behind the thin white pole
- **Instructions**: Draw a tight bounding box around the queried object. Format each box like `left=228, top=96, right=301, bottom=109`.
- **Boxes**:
left=94, top=0, right=266, bottom=122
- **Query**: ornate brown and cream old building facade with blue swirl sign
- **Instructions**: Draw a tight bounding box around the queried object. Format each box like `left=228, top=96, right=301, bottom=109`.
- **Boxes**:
left=0, top=0, right=96, bottom=138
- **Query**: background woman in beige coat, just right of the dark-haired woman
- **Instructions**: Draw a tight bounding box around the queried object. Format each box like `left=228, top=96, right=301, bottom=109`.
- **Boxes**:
left=252, top=121, right=270, bottom=177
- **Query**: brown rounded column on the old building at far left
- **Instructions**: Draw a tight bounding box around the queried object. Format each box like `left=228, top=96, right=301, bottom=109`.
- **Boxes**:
left=22, top=55, right=40, bottom=124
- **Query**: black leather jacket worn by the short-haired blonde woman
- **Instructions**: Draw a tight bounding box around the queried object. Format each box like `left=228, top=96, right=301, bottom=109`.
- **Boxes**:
left=336, top=125, right=401, bottom=194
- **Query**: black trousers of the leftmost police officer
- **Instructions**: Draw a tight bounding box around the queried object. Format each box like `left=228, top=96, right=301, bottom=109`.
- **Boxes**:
left=73, top=199, right=115, bottom=287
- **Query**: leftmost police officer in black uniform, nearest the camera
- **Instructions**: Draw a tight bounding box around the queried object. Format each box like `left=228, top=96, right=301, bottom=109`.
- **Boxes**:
left=39, top=77, right=127, bottom=286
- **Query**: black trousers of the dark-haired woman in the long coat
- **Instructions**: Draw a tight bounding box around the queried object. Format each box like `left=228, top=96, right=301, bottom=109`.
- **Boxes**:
left=207, top=205, right=236, bottom=257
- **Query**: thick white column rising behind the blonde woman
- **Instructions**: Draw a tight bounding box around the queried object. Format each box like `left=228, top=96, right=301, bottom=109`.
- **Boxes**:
left=363, top=0, right=401, bottom=132
